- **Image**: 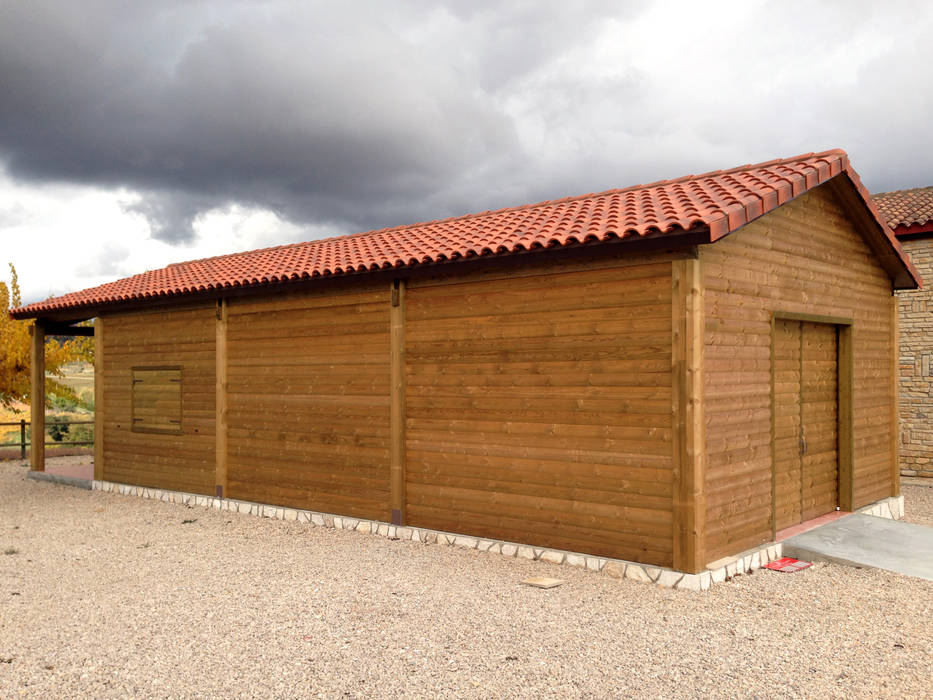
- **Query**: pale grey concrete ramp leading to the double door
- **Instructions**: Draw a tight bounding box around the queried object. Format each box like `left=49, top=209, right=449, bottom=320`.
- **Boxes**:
left=784, top=513, right=933, bottom=581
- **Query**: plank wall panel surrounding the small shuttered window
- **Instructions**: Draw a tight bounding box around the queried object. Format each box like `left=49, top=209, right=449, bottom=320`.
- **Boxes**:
left=102, top=305, right=215, bottom=494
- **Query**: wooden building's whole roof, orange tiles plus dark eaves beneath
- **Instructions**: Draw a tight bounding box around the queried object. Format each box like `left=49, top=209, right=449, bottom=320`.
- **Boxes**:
left=11, top=149, right=920, bottom=322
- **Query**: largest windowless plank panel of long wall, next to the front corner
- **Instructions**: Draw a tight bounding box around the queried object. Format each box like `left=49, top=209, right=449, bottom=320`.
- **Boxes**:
left=405, top=256, right=673, bottom=565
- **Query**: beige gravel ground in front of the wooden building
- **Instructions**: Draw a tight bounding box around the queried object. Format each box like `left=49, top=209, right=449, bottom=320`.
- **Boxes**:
left=0, top=463, right=933, bottom=697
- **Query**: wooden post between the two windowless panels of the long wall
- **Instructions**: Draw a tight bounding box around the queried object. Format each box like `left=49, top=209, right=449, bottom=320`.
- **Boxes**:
left=389, top=280, right=405, bottom=525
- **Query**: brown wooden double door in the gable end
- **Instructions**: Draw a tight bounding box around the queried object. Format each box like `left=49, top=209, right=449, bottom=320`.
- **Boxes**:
left=772, top=319, right=839, bottom=530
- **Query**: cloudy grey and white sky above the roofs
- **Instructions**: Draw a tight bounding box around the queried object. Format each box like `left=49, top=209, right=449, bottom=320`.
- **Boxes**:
left=0, top=0, right=933, bottom=302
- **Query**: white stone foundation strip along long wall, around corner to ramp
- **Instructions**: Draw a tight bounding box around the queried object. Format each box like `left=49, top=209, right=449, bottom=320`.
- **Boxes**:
left=92, top=480, right=780, bottom=591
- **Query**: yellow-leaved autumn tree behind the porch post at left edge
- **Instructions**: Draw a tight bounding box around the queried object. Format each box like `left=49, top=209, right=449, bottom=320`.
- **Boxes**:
left=0, top=263, right=93, bottom=408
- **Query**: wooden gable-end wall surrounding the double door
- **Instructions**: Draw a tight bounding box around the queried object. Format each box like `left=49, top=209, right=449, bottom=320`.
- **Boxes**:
left=700, top=185, right=895, bottom=561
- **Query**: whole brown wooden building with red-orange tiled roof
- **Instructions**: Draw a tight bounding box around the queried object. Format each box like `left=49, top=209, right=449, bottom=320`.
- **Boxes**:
left=13, top=151, right=919, bottom=572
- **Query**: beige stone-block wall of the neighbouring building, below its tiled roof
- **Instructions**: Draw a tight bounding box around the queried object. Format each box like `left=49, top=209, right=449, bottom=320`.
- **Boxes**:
left=897, top=237, right=933, bottom=478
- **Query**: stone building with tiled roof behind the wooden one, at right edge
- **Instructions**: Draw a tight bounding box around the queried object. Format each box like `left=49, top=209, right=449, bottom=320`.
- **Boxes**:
left=872, top=187, right=933, bottom=478
